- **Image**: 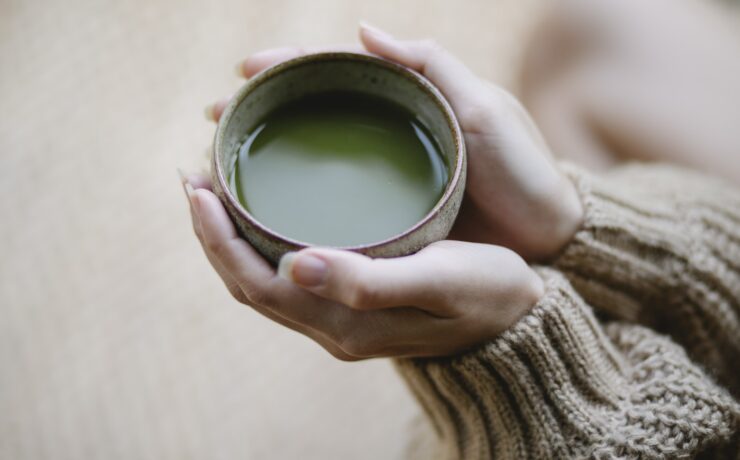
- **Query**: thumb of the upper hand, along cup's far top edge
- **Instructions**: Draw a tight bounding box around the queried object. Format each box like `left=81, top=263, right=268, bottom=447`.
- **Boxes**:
left=360, top=23, right=487, bottom=116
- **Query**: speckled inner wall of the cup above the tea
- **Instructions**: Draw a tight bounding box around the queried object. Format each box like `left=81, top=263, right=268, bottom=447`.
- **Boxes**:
left=216, top=53, right=458, bottom=203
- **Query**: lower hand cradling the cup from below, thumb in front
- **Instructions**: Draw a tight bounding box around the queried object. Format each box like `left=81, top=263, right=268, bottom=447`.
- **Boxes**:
left=184, top=175, right=543, bottom=361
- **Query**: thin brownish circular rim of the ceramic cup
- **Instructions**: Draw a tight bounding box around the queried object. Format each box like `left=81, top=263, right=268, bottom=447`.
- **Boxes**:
left=212, top=51, right=465, bottom=252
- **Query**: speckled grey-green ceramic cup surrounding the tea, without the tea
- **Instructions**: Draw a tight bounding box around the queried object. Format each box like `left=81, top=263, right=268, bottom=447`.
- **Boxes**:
left=211, top=53, right=466, bottom=265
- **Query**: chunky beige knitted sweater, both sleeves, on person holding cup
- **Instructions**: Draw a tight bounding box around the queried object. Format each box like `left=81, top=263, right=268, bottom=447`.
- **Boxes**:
left=395, top=166, right=740, bottom=459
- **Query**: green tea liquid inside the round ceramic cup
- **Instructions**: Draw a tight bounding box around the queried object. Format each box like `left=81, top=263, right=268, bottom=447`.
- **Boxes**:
left=230, top=92, right=448, bottom=246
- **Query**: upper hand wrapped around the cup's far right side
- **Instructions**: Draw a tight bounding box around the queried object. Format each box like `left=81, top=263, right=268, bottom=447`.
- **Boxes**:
left=208, top=26, right=583, bottom=260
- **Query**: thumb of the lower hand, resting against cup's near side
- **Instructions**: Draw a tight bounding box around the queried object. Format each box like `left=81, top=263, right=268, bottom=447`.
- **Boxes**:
left=278, top=248, right=442, bottom=310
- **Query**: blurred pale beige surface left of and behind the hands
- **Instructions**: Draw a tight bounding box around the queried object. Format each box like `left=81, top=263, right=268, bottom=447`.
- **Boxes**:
left=0, top=0, right=536, bottom=459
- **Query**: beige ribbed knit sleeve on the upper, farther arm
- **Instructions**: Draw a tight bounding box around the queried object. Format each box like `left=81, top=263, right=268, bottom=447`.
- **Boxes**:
left=553, top=165, right=740, bottom=397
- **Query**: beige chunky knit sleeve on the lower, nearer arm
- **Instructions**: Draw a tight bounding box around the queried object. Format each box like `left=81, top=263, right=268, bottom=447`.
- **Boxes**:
left=395, top=269, right=740, bottom=459
